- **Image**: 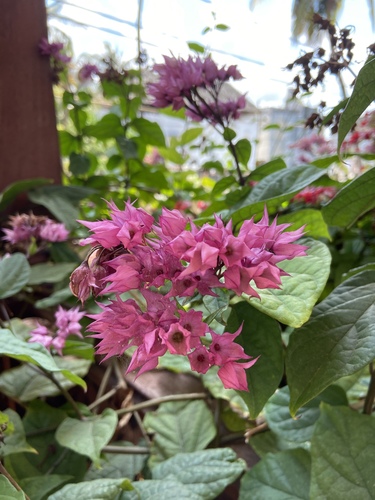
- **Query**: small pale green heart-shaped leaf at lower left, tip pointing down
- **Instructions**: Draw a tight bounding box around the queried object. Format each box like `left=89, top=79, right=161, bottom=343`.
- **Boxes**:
left=56, top=408, right=117, bottom=466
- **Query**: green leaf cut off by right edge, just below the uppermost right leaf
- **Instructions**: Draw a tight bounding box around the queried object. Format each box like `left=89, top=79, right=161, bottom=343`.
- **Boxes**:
left=322, top=168, right=375, bottom=227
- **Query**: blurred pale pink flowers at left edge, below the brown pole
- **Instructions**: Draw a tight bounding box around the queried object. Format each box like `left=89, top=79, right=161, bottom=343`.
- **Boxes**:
left=2, top=213, right=69, bottom=245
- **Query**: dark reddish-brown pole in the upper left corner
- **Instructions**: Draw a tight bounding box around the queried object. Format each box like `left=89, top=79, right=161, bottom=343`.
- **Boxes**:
left=0, top=0, right=61, bottom=191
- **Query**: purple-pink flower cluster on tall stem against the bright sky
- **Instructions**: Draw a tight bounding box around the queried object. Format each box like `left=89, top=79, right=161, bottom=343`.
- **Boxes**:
left=148, top=56, right=246, bottom=127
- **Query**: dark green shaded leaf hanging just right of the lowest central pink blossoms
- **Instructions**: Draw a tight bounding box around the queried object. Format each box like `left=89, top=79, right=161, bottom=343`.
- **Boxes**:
left=227, top=302, right=284, bottom=419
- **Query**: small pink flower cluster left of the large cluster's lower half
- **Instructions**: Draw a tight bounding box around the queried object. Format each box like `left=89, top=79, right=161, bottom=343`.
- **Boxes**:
left=29, top=306, right=86, bottom=356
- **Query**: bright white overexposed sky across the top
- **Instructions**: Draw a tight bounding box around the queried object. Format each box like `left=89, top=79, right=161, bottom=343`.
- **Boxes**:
left=47, top=0, right=375, bottom=108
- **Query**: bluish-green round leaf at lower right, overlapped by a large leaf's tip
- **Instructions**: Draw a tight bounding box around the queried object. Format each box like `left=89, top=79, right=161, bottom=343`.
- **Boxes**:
left=264, top=385, right=348, bottom=444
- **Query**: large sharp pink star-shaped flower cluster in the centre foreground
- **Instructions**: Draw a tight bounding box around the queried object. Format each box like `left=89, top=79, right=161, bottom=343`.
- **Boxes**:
left=71, top=201, right=307, bottom=390
